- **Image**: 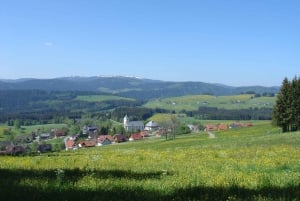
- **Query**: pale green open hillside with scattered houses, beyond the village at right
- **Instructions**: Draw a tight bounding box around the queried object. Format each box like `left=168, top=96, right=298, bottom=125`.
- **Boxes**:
left=144, top=94, right=276, bottom=112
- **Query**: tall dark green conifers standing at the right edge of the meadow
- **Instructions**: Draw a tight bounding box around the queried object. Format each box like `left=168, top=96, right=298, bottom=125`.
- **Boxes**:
left=272, top=77, right=300, bottom=132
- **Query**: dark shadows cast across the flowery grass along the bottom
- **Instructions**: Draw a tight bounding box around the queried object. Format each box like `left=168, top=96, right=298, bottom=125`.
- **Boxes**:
left=0, top=169, right=300, bottom=201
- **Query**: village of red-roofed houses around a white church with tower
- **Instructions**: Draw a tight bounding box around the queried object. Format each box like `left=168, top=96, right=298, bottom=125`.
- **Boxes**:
left=0, top=115, right=253, bottom=155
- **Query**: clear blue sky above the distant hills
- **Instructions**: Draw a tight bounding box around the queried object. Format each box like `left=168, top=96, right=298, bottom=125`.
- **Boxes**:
left=0, top=0, right=300, bottom=86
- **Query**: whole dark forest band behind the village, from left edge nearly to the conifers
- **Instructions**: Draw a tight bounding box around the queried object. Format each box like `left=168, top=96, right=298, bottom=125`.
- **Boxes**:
left=0, top=90, right=272, bottom=125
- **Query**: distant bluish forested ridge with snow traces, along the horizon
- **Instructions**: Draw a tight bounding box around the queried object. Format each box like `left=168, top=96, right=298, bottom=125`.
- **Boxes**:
left=0, top=76, right=279, bottom=99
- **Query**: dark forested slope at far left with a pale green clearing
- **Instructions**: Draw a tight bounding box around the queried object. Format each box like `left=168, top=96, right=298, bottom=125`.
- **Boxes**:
left=0, top=90, right=143, bottom=126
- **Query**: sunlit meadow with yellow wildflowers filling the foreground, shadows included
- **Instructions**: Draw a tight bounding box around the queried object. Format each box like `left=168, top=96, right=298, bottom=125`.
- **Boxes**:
left=0, top=121, right=300, bottom=201
